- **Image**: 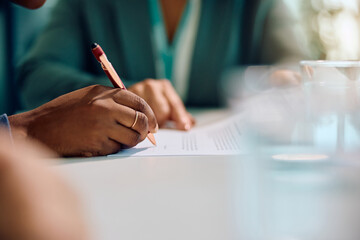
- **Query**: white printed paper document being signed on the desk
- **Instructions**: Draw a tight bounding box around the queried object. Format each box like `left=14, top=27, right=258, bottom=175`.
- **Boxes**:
left=110, top=116, right=244, bottom=156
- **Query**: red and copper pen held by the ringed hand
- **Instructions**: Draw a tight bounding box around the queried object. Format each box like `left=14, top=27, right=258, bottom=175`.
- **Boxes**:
left=91, top=43, right=156, bottom=145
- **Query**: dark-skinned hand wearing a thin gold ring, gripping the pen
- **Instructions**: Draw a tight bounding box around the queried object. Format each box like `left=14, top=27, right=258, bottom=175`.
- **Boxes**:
left=9, top=85, right=157, bottom=157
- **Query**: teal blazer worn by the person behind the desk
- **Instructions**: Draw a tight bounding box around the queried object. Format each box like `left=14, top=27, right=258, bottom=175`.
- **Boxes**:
left=18, top=0, right=300, bottom=108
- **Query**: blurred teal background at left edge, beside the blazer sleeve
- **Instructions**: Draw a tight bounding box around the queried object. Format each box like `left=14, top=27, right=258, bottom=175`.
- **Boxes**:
left=0, top=0, right=58, bottom=115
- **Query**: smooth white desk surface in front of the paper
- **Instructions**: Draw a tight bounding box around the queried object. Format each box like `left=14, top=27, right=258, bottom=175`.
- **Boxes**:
left=58, top=109, right=360, bottom=240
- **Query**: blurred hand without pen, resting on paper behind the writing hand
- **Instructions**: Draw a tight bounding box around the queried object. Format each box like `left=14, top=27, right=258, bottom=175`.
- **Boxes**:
left=129, top=79, right=195, bottom=130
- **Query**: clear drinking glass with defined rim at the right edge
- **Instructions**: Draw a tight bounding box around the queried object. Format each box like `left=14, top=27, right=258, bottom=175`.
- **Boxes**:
left=300, top=61, right=360, bottom=152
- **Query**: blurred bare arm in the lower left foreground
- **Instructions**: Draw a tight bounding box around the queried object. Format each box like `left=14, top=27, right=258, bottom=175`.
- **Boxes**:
left=0, top=135, right=91, bottom=240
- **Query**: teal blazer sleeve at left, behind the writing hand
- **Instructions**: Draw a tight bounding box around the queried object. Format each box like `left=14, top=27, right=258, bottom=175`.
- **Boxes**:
left=17, top=0, right=115, bottom=108
